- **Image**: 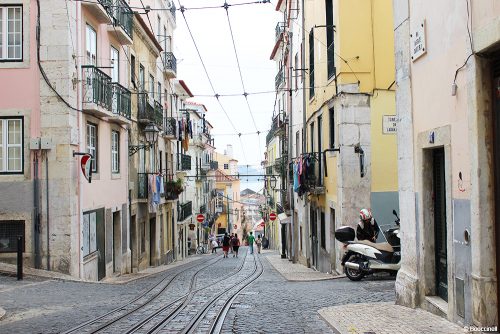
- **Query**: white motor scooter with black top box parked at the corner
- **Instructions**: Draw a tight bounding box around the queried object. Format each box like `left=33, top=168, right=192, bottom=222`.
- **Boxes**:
left=335, top=210, right=401, bottom=281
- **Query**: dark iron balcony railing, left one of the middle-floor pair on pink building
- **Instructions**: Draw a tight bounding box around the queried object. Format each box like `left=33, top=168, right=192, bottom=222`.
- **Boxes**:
left=82, top=65, right=112, bottom=110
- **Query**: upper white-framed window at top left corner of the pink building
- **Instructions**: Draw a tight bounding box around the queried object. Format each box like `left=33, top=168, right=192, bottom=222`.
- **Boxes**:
left=0, top=6, right=23, bottom=61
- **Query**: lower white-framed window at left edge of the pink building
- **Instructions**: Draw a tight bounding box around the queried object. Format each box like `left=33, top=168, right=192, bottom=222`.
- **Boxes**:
left=0, top=118, right=23, bottom=173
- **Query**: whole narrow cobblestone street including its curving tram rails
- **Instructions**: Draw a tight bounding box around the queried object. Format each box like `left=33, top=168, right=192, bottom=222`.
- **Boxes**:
left=0, top=248, right=394, bottom=333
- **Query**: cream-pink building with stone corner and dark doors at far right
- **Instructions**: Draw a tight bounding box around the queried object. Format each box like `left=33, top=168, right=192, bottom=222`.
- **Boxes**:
left=393, top=0, right=500, bottom=326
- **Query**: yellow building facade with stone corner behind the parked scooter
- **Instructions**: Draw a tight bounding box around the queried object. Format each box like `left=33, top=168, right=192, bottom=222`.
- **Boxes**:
left=299, top=0, right=398, bottom=272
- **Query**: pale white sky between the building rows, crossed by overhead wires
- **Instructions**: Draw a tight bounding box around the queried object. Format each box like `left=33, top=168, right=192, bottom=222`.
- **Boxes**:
left=174, top=0, right=280, bottom=172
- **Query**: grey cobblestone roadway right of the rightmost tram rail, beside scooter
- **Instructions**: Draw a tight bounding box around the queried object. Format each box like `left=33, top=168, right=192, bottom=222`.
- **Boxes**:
left=222, top=253, right=395, bottom=334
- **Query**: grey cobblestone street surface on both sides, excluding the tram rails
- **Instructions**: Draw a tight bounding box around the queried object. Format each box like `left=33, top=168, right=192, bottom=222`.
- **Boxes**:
left=0, top=247, right=394, bottom=334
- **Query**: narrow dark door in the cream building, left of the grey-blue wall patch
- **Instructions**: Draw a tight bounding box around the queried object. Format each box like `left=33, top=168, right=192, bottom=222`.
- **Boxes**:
left=432, top=148, right=448, bottom=301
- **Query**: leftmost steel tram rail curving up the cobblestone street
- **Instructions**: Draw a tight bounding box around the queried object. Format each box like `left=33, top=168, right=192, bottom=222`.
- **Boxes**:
left=61, top=256, right=222, bottom=334
